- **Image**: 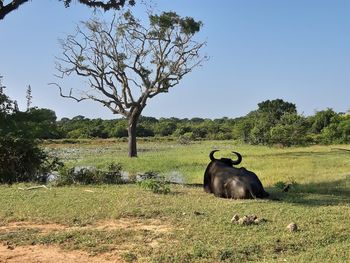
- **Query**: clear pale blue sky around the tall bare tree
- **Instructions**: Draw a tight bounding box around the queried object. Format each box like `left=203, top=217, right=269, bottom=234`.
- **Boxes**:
left=0, top=0, right=350, bottom=119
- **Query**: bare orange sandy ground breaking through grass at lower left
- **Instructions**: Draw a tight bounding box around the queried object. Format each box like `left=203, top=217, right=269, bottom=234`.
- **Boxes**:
left=0, top=218, right=171, bottom=263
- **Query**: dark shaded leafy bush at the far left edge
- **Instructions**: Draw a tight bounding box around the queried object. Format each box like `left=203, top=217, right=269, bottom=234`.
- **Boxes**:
left=0, top=78, right=55, bottom=183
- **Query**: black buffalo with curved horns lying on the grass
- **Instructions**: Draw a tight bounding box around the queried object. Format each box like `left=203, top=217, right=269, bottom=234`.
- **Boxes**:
left=204, top=150, right=269, bottom=199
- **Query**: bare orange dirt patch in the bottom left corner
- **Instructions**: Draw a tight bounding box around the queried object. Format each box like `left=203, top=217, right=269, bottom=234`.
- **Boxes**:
left=0, top=245, right=124, bottom=263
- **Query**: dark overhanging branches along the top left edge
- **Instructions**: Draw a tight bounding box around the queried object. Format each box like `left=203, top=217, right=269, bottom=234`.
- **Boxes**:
left=0, top=0, right=135, bottom=20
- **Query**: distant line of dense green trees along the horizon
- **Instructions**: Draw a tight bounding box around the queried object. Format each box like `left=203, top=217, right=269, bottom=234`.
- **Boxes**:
left=18, top=99, right=350, bottom=146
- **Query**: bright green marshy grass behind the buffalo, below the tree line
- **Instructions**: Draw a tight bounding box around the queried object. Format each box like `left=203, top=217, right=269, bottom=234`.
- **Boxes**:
left=48, top=141, right=350, bottom=186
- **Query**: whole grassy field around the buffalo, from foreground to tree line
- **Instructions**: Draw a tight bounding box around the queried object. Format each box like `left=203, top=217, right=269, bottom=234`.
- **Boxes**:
left=0, top=141, right=350, bottom=262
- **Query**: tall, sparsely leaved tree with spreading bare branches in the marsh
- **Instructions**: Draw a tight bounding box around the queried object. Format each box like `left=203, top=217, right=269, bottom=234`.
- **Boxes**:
left=55, top=11, right=206, bottom=157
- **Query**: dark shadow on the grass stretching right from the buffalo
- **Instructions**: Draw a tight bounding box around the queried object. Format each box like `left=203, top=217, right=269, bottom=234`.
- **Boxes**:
left=266, top=175, right=350, bottom=206
